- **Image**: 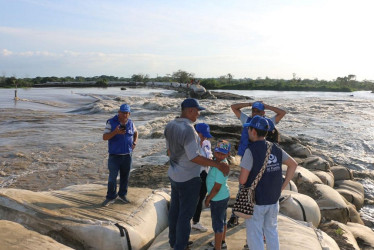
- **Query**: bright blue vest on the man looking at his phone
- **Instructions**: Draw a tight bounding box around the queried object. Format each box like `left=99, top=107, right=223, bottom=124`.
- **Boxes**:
left=107, top=115, right=135, bottom=155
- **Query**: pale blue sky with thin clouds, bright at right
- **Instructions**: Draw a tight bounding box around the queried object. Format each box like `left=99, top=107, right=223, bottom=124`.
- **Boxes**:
left=0, top=0, right=374, bottom=80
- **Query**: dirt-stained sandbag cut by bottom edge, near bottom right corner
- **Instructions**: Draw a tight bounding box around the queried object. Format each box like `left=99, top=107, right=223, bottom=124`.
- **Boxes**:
left=319, top=220, right=360, bottom=250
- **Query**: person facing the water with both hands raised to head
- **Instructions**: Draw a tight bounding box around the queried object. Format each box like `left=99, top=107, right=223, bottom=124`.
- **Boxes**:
left=227, top=101, right=286, bottom=228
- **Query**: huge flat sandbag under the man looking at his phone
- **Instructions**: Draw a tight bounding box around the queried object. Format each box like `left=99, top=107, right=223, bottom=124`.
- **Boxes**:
left=0, top=184, right=170, bottom=249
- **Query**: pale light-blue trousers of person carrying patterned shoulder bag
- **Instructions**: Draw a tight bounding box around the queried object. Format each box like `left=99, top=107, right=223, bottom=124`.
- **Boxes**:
left=245, top=202, right=279, bottom=250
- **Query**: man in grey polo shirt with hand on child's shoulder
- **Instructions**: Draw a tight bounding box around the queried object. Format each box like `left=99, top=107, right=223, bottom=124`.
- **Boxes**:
left=164, top=98, right=230, bottom=250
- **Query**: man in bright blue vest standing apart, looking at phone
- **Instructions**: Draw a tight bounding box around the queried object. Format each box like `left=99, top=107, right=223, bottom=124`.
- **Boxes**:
left=102, top=104, right=138, bottom=206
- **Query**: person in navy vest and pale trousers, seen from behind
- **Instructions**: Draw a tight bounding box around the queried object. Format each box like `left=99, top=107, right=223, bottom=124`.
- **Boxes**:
left=239, top=116, right=297, bottom=250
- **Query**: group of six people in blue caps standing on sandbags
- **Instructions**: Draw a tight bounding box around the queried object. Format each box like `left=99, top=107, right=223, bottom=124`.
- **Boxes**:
left=103, top=98, right=297, bottom=250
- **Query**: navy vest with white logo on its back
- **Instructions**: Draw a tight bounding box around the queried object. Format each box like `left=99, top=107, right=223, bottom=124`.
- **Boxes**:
left=245, top=140, right=283, bottom=205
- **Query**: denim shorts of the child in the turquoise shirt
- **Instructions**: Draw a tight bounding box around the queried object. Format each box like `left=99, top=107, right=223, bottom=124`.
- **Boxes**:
left=210, top=197, right=230, bottom=233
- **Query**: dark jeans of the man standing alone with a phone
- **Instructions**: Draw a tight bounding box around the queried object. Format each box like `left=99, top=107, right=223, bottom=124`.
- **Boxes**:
left=106, top=154, right=132, bottom=200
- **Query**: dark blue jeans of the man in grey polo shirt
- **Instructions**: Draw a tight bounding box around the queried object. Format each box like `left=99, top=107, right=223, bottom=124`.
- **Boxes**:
left=169, top=177, right=201, bottom=250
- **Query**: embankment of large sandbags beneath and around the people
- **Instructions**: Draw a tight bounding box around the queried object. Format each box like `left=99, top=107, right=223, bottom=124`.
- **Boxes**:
left=0, top=124, right=374, bottom=249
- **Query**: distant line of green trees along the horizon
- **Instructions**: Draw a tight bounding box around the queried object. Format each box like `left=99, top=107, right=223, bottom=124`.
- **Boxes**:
left=0, top=70, right=374, bottom=92
